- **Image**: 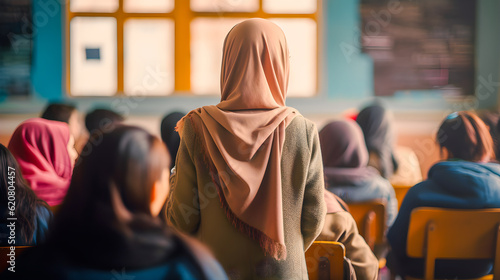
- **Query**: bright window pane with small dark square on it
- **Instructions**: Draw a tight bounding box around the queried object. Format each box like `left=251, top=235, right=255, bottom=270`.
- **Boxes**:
left=70, top=17, right=117, bottom=96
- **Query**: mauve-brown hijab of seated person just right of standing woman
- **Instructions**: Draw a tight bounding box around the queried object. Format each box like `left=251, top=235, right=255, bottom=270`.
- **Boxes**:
left=319, top=121, right=377, bottom=187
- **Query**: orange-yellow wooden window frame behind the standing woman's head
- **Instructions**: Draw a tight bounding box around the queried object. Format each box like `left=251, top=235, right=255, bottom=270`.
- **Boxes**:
left=64, top=0, right=322, bottom=98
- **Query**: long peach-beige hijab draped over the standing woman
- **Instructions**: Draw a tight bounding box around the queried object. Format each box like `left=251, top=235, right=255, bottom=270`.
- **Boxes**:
left=178, top=19, right=299, bottom=259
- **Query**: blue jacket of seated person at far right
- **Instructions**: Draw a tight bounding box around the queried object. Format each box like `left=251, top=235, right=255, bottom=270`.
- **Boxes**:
left=387, top=161, right=500, bottom=278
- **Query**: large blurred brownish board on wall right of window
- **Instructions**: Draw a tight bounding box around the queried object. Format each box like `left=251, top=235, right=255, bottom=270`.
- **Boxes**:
left=360, top=0, right=476, bottom=96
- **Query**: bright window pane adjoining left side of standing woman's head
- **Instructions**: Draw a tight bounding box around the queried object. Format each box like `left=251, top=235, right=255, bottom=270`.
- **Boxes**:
left=191, top=18, right=243, bottom=95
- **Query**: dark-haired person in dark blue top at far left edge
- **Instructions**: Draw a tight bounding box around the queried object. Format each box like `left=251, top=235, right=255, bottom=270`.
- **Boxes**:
left=0, top=144, right=52, bottom=246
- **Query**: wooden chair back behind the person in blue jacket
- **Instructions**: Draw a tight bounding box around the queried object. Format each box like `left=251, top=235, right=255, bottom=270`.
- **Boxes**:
left=406, top=207, right=500, bottom=280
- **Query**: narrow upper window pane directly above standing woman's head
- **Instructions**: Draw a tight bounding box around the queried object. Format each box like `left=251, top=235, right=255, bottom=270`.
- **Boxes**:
left=191, top=0, right=259, bottom=12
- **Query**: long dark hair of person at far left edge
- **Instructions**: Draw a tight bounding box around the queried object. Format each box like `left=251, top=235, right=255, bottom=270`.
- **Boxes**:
left=0, top=144, right=49, bottom=245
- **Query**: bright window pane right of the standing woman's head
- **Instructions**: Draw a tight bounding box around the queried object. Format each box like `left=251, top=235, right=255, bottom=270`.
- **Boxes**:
left=271, top=18, right=318, bottom=97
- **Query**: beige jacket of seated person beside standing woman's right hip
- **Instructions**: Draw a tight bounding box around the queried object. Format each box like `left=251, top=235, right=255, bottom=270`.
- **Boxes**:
left=316, top=190, right=378, bottom=280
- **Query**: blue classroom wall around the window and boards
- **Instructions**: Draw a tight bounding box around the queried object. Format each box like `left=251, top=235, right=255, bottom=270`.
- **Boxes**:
left=0, top=0, right=500, bottom=114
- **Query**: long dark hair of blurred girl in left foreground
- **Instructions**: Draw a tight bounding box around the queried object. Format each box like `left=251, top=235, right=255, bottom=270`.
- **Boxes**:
left=49, top=126, right=171, bottom=269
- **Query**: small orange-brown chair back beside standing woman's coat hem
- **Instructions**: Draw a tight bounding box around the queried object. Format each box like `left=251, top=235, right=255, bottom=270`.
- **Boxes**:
left=305, top=241, right=345, bottom=280
